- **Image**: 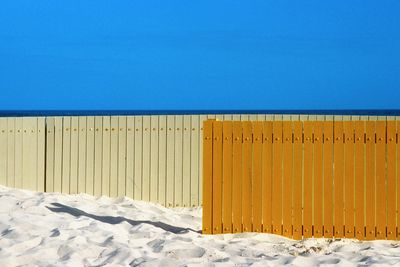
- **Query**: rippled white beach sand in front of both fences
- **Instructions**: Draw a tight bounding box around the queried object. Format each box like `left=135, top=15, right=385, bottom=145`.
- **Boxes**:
left=0, top=187, right=400, bottom=267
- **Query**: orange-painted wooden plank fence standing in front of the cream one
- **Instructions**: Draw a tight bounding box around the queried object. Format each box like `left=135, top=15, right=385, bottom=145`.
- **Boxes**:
left=203, top=120, right=400, bottom=240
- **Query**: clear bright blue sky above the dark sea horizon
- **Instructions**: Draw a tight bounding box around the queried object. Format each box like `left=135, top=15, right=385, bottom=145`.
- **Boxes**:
left=0, top=0, right=400, bottom=110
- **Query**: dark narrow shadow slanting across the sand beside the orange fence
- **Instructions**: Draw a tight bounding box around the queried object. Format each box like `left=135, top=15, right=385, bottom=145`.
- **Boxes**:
left=46, top=203, right=201, bottom=234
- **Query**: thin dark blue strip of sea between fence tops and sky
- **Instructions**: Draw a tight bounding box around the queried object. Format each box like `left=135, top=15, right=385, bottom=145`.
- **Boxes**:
left=0, top=109, right=400, bottom=117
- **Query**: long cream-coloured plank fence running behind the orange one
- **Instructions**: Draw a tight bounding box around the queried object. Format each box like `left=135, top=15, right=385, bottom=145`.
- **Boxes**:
left=0, top=115, right=393, bottom=207
